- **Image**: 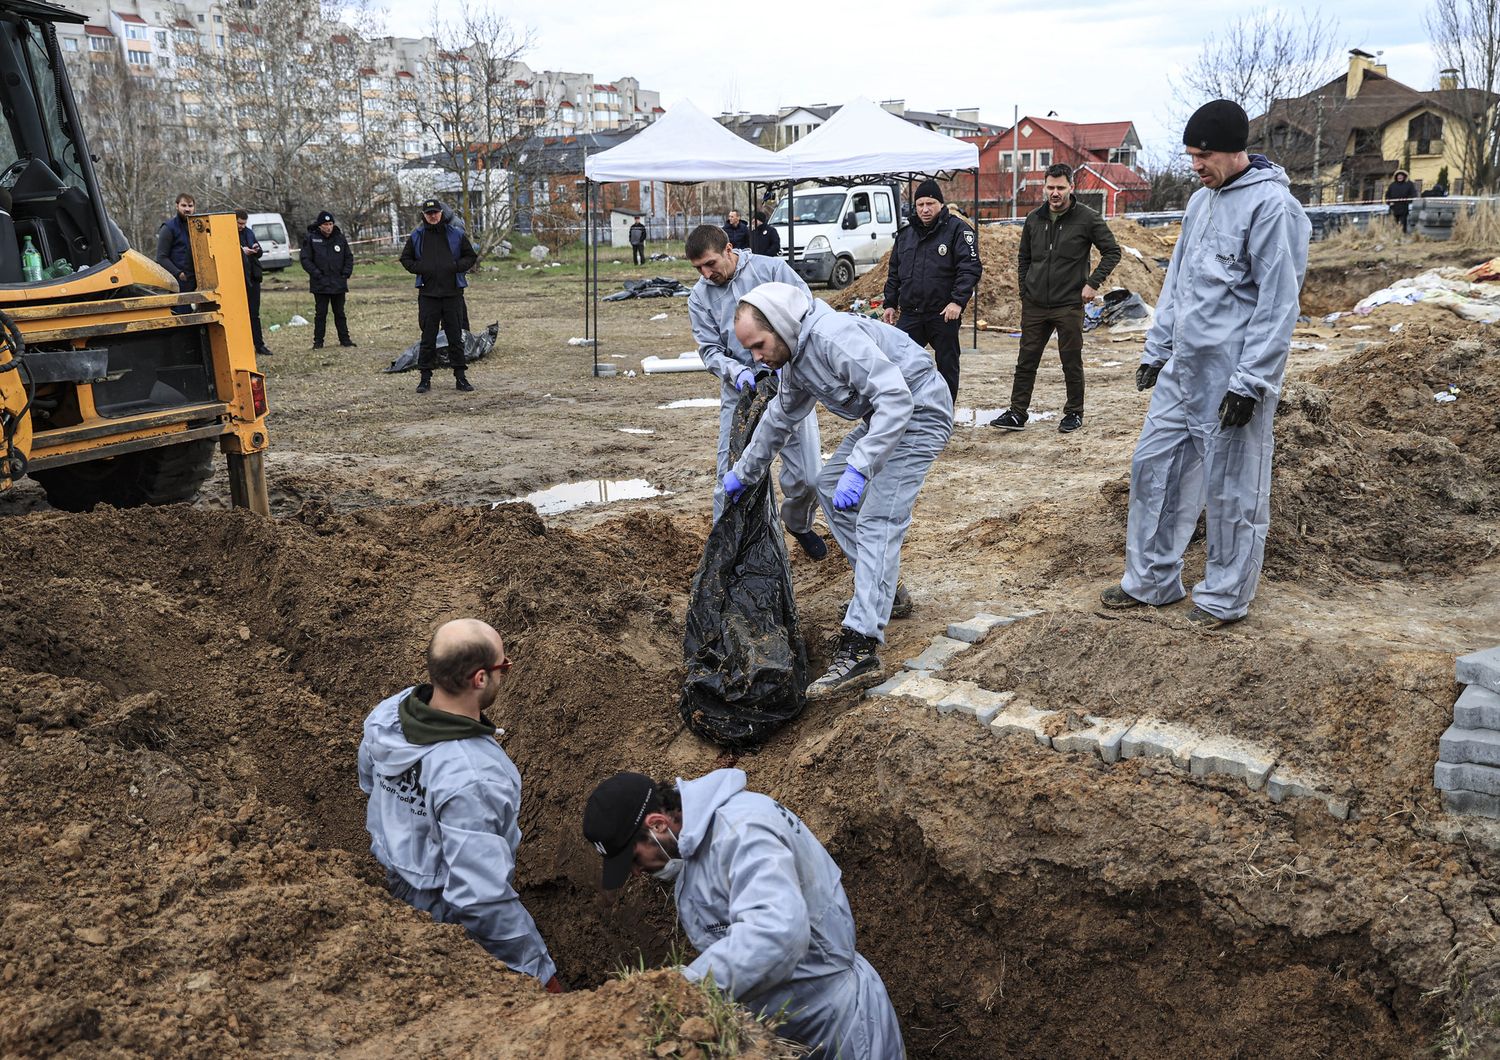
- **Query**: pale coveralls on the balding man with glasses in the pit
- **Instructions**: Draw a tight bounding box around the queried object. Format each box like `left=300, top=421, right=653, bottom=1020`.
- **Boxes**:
left=359, top=688, right=557, bottom=984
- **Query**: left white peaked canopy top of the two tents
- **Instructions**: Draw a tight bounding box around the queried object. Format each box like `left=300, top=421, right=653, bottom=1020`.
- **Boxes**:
left=584, top=99, right=789, bottom=184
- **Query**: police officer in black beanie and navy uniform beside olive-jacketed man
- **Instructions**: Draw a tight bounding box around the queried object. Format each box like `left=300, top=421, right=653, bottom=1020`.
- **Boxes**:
left=882, top=180, right=984, bottom=402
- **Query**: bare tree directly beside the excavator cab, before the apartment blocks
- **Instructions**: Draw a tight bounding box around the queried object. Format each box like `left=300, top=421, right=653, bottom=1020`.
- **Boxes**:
left=72, top=51, right=186, bottom=255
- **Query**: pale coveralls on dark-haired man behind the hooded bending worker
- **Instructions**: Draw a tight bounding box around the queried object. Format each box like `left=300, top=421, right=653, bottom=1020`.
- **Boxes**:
left=687, top=250, right=822, bottom=534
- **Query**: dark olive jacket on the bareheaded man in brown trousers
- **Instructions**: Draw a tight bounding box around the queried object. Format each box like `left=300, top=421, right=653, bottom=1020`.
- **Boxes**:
left=1016, top=201, right=1121, bottom=312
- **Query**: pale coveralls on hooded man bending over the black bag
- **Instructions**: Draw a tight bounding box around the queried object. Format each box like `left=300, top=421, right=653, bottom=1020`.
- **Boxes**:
left=734, top=283, right=953, bottom=643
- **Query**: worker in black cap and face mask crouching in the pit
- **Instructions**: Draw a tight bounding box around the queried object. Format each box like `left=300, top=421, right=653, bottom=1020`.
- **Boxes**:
left=584, top=773, right=900, bottom=1060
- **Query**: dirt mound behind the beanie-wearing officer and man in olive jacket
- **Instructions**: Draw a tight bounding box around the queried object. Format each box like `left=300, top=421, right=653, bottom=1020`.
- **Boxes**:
left=828, top=219, right=1173, bottom=331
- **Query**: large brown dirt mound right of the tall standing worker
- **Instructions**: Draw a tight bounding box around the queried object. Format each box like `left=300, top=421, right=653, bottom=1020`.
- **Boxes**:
left=1266, top=321, right=1500, bottom=579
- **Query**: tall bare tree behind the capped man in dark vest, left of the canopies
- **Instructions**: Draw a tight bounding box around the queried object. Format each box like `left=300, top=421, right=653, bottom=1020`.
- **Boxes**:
left=402, top=3, right=561, bottom=258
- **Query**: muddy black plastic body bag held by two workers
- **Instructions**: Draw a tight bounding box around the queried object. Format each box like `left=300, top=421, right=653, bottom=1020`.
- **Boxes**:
left=678, top=375, right=807, bottom=751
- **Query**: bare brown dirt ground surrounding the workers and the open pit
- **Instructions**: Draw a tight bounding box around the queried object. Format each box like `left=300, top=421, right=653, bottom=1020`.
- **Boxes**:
left=0, top=250, right=1500, bottom=1059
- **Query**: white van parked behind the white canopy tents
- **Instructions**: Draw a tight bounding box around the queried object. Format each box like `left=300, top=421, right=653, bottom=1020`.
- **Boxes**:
left=770, top=184, right=903, bottom=288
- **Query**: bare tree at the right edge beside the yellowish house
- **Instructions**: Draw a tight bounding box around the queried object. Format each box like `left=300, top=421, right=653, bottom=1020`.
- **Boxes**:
left=1425, top=0, right=1500, bottom=192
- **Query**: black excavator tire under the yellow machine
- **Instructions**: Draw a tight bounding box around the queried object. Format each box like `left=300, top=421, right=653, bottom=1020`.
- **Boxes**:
left=33, top=439, right=218, bottom=511
